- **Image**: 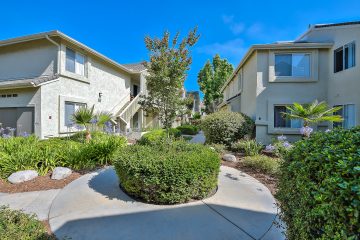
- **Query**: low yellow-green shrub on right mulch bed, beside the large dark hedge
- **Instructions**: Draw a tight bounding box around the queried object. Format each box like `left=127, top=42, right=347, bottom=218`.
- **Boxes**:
left=243, top=155, right=281, bottom=175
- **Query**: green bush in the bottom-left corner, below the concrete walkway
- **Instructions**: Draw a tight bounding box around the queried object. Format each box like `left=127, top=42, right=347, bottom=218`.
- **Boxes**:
left=0, top=206, right=55, bottom=240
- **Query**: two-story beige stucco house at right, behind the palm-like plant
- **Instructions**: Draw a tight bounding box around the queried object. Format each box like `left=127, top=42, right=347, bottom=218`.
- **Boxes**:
left=219, top=22, right=360, bottom=144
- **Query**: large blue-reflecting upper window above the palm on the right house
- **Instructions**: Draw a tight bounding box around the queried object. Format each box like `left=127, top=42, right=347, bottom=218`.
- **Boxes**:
left=275, top=53, right=310, bottom=78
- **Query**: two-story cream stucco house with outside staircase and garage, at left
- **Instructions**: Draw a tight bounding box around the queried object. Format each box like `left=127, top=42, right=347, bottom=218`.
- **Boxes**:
left=0, top=31, right=157, bottom=138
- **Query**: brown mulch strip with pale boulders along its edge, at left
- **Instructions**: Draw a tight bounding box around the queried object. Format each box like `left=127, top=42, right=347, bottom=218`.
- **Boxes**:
left=0, top=171, right=88, bottom=193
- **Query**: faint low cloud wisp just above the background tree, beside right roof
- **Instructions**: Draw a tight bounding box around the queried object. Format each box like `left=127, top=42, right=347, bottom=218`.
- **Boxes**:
left=196, top=38, right=246, bottom=65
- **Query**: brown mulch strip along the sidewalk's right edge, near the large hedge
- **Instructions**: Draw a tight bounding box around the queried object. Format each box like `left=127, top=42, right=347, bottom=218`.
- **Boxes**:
left=221, top=154, right=278, bottom=195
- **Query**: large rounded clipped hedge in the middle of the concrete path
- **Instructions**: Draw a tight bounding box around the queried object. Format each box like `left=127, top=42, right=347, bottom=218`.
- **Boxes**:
left=114, top=141, right=220, bottom=204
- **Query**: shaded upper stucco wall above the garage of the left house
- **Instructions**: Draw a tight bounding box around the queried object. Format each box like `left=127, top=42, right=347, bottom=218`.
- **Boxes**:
left=0, top=40, right=57, bottom=80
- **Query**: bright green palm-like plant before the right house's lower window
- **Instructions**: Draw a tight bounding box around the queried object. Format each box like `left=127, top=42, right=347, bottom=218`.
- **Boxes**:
left=282, top=100, right=343, bottom=127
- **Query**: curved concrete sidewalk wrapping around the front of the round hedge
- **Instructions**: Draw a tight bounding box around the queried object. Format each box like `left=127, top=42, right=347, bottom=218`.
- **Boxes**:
left=49, top=167, right=284, bottom=240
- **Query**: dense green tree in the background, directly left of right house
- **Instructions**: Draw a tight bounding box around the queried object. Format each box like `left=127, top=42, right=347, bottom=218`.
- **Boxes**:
left=198, top=54, right=234, bottom=113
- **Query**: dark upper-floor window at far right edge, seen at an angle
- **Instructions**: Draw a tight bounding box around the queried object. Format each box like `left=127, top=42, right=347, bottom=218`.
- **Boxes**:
left=334, top=42, right=355, bottom=73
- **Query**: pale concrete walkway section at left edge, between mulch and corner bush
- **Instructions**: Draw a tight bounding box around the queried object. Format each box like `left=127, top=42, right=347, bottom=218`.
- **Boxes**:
left=0, top=189, right=60, bottom=220
